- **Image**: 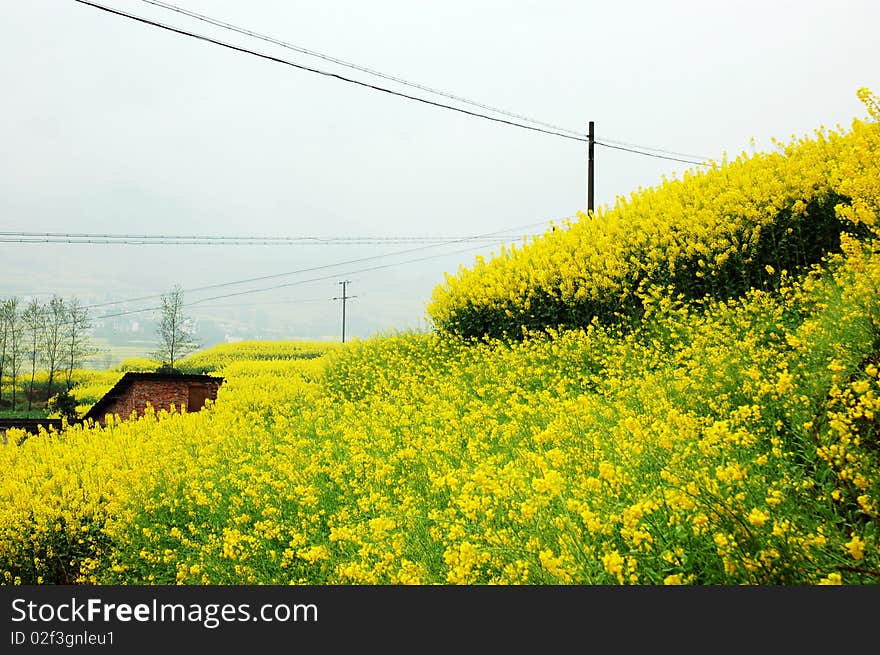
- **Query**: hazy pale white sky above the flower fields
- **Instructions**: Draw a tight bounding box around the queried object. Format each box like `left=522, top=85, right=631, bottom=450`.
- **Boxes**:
left=0, top=0, right=880, bottom=344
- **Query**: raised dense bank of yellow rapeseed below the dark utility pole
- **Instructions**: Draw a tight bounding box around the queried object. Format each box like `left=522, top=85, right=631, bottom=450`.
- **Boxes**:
left=428, top=89, right=880, bottom=337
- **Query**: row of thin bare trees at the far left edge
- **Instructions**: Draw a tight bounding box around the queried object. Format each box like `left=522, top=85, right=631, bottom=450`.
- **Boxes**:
left=0, top=295, right=94, bottom=412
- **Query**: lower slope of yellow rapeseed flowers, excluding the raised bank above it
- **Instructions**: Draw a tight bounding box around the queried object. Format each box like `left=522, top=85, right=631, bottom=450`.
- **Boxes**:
left=0, top=250, right=880, bottom=584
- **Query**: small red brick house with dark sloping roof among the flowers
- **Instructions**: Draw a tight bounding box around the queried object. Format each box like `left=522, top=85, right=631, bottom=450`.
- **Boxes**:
left=82, top=371, right=223, bottom=424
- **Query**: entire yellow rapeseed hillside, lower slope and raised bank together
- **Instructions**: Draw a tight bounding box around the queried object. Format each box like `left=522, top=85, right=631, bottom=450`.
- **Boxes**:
left=0, top=92, right=880, bottom=585
